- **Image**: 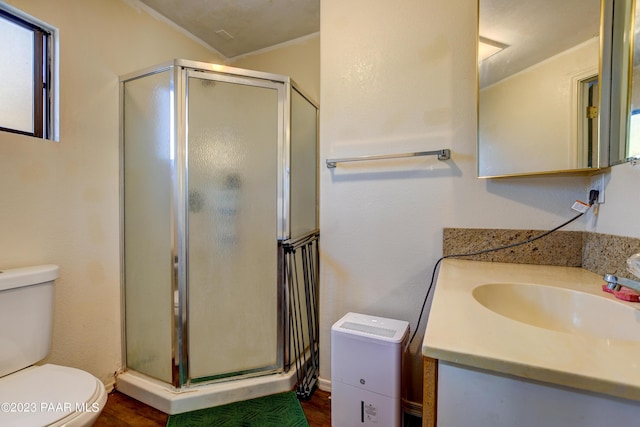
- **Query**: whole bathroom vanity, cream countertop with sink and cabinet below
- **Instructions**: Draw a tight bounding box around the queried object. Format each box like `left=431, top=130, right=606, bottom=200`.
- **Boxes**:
left=422, top=259, right=640, bottom=427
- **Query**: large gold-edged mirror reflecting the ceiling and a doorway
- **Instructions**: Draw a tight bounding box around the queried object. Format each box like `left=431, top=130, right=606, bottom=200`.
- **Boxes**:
left=478, top=0, right=608, bottom=177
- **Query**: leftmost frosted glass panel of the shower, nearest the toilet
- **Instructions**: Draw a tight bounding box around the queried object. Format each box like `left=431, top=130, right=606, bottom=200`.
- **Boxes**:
left=122, top=71, right=173, bottom=382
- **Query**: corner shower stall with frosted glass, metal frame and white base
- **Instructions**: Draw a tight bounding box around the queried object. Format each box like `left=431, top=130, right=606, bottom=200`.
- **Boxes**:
left=117, top=60, right=318, bottom=413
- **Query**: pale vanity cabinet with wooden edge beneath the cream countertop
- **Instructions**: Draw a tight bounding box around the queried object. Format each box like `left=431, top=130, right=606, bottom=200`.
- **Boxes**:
left=422, top=357, right=640, bottom=427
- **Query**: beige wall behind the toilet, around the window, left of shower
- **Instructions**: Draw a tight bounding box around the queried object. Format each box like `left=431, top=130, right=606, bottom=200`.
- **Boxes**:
left=0, top=0, right=221, bottom=384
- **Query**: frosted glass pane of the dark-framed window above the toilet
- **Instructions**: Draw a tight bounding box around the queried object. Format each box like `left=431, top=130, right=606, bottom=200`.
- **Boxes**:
left=0, top=17, right=33, bottom=132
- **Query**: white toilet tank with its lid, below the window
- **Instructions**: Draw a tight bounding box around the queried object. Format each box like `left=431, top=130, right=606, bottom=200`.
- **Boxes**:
left=0, top=265, right=58, bottom=377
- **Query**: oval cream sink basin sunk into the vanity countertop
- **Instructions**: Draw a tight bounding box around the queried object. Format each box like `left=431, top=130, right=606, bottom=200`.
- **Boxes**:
left=473, top=283, right=640, bottom=341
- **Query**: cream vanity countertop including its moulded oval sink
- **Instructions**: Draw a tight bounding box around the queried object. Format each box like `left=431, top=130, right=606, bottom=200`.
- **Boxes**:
left=422, top=259, right=640, bottom=404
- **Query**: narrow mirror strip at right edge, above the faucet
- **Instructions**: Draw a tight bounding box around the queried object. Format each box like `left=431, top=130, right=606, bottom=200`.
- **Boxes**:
left=611, top=0, right=640, bottom=164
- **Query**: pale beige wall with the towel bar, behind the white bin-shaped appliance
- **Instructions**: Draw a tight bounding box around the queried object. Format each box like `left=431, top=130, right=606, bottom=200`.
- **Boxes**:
left=320, top=0, right=604, bottom=402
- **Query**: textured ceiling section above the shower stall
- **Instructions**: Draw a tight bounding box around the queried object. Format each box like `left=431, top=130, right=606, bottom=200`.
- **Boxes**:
left=140, top=0, right=320, bottom=58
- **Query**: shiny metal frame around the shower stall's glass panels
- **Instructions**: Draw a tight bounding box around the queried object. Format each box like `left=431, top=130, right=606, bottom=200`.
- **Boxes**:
left=120, top=60, right=319, bottom=389
